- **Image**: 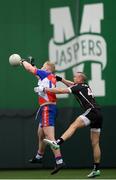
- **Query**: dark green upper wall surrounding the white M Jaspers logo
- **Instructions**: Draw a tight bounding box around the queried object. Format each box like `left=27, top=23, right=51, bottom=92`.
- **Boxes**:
left=0, top=0, right=116, bottom=109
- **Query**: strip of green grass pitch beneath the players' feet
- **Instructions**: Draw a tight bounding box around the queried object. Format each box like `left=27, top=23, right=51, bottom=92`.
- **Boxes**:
left=0, top=169, right=116, bottom=179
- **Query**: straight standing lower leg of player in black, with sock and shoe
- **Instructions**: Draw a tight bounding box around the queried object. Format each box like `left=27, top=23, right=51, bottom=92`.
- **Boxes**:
left=88, top=130, right=101, bottom=178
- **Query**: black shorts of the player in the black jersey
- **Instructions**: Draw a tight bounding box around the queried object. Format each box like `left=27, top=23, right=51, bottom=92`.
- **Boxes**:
left=85, top=108, right=103, bottom=129
